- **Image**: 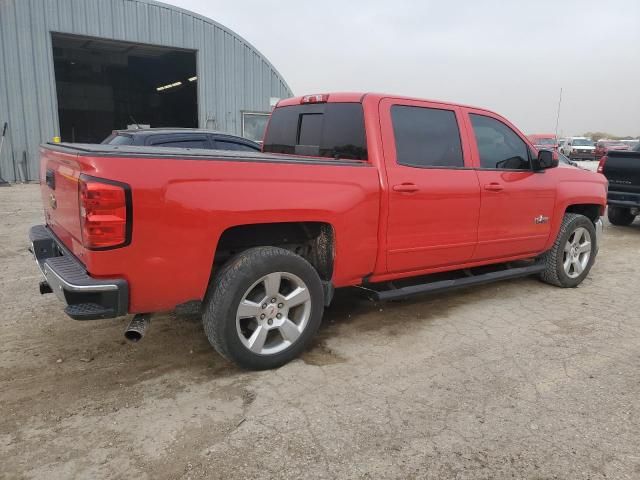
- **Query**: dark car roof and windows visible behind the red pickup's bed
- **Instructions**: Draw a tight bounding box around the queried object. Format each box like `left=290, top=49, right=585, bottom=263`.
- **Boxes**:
left=102, top=128, right=260, bottom=152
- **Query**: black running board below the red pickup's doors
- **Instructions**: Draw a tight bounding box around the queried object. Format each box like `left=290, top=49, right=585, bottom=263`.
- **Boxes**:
left=365, top=263, right=546, bottom=301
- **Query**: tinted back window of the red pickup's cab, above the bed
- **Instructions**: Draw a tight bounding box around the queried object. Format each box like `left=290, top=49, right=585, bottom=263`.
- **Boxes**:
left=263, top=103, right=367, bottom=160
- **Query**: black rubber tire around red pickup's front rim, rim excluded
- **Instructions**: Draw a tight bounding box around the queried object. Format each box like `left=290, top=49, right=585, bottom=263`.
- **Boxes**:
left=540, top=213, right=598, bottom=288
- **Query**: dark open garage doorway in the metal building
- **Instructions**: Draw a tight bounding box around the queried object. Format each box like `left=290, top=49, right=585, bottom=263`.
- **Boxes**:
left=52, top=33, right=198, bottom=143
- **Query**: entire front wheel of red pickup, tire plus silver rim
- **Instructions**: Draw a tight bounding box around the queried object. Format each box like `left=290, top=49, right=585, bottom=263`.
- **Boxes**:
left=540, top=213, right=598, bottom=288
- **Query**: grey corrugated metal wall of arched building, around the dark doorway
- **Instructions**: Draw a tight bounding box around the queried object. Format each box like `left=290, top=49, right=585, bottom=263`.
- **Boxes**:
left=0, top=0, right=292, bottom=181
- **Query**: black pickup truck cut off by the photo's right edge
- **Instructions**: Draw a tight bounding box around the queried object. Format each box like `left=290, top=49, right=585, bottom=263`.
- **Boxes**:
left=598, top=144, right=640, bottom=226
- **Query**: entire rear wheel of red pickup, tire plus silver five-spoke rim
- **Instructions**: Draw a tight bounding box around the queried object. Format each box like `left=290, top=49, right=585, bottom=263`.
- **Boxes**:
left=202, top=247, right=324, bottom=370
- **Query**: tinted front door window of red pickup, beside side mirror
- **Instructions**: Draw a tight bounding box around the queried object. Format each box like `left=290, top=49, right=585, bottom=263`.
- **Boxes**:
left=469, top=113, right=531, bottom=170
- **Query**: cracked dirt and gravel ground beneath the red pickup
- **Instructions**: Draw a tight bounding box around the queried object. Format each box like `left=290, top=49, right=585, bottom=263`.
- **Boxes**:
left=0, top=185, right=640, bottom=480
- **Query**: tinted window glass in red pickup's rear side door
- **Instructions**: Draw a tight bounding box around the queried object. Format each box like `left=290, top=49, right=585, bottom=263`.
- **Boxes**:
left=391, top=105, right=464, bottom=168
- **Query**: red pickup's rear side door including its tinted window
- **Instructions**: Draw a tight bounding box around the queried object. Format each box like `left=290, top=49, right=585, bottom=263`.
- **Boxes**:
left=380, top=99, right=480, bottom=272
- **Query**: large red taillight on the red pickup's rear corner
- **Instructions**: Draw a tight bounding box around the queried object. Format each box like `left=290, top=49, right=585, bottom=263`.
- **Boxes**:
left=78, top=176, right=131, bottom=250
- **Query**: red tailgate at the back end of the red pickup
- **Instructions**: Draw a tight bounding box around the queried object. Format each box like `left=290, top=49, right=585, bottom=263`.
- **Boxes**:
left=40, top=147, right=82, bottom=249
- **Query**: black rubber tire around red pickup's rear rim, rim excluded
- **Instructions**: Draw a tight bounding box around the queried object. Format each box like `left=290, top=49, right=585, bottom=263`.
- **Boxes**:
left=202, top=247, right=324, bottom=370
